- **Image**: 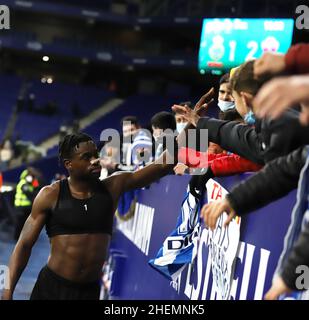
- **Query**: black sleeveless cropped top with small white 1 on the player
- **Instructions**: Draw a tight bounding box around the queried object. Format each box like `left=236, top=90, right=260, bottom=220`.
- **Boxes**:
left=46, top=179, right=114, bottom=238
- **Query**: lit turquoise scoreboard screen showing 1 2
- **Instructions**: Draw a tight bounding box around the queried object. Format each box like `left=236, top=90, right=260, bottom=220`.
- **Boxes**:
left=198, top=18, right=294, bottom=74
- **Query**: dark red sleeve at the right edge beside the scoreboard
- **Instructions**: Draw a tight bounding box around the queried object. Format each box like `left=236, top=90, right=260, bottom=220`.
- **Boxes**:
left=285, top=43, right=309, bottom=73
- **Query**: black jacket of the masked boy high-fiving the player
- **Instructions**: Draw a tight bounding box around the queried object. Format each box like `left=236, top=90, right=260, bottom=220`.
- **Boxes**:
left=197, top=109, right=309, bottom=165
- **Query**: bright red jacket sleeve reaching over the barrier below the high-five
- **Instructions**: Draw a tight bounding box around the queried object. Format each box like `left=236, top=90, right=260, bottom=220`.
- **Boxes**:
left=178, top=148, right=262, bottom=177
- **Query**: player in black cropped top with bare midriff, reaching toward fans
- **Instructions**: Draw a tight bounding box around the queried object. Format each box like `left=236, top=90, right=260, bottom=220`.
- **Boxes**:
left=2, top=133, right=173, bottom=300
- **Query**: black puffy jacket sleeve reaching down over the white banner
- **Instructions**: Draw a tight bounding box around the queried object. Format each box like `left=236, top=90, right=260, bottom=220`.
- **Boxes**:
left=227, top=146, right=309, bottom=216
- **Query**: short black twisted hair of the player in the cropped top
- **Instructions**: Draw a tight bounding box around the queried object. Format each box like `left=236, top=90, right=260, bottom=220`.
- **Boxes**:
left=58, top=132, right=94, bottom=163
